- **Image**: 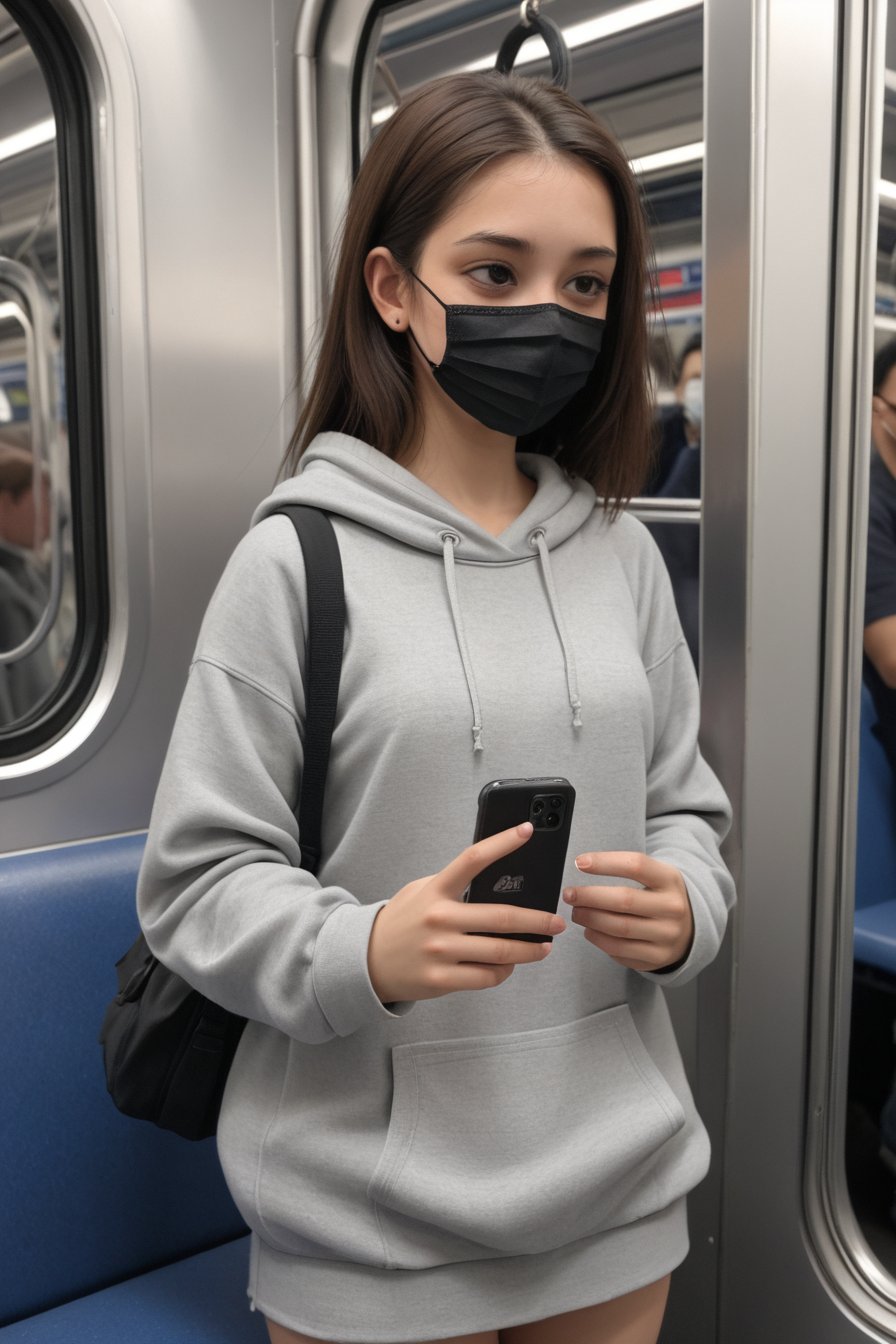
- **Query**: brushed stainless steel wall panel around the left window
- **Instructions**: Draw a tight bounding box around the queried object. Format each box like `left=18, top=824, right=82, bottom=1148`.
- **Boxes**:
left=0, top=0, right=298, bottom=849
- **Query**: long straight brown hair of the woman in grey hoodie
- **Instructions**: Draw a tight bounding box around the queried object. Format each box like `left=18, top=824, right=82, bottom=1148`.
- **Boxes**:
left=282, top=73, right=652, bottom=512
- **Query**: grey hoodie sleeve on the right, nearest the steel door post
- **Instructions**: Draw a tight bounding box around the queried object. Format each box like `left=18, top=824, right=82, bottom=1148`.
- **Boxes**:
left=631, top=526, right=735, bottom=988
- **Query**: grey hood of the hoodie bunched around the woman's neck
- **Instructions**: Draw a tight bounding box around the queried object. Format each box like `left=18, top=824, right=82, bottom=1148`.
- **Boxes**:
left=253, top=433, right=595, bottom=564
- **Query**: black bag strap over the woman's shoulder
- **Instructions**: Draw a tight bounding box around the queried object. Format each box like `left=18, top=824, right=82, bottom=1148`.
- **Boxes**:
left=268, top=504, right=345, bottom=872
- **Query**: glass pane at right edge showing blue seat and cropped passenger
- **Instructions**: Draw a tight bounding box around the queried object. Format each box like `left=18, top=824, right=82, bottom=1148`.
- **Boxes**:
left=846, top=4, right=896, bottom=1277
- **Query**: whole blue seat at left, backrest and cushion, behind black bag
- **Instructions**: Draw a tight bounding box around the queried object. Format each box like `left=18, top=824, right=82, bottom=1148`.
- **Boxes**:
left=0, top=836, right=259, bottom=1344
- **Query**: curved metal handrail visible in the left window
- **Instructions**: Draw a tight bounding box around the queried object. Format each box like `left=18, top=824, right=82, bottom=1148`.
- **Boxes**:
left=0, top=257, right=63, bottom=667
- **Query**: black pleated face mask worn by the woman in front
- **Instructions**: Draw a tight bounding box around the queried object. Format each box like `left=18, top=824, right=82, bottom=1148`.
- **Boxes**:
left=408, top=271, right=606, bottom=438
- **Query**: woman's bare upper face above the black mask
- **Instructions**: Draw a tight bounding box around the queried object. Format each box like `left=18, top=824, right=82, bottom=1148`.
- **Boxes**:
left=407, top=155, right=617, bottom=364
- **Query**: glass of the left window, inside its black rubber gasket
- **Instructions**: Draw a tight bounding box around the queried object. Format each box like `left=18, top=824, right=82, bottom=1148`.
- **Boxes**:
left=0, top=7, right=77, bottom=735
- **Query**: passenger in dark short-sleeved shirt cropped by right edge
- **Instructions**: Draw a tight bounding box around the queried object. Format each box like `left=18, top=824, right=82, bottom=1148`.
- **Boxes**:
left=864, top=340, right=896, bottom=771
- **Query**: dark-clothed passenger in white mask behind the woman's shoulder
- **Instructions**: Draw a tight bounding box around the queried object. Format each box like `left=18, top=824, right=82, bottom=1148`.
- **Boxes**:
left=650, top=332, right=703, bottom=667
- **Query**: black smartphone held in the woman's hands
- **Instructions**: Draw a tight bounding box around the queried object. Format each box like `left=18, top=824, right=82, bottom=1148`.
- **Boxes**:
left=465, top=777, right=575, bottom=942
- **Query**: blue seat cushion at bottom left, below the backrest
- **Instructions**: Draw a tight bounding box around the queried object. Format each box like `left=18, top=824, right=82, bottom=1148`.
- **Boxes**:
left=0, top=1236, right=267, bottom=1344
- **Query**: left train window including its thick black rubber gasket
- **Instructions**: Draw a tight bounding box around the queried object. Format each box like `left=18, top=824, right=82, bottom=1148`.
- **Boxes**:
left=0, top=0, right=105, bottom=761
